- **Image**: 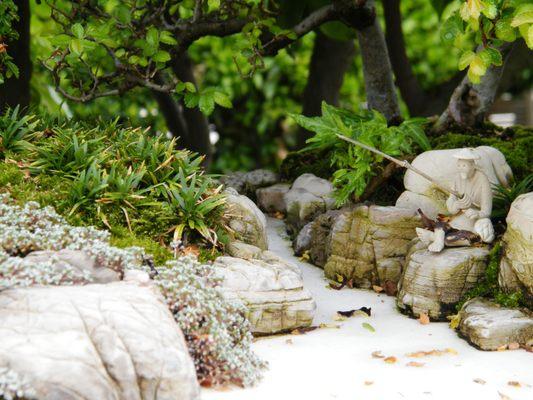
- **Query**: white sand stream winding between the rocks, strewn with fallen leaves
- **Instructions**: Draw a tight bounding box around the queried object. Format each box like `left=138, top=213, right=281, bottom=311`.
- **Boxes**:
left=202, top=219, right=533, bottom=400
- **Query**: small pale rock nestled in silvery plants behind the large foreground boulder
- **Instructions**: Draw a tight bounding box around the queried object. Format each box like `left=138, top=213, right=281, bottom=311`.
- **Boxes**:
left=23, top=249, right=121, bottom=283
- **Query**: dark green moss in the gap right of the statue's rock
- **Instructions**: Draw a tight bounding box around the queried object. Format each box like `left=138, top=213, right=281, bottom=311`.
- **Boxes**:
left=456, top=242, right=524, bottom=311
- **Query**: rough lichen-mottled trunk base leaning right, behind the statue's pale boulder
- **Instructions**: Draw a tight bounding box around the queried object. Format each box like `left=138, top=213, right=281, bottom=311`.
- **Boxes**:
left=435, top=44, right=512, bottom=131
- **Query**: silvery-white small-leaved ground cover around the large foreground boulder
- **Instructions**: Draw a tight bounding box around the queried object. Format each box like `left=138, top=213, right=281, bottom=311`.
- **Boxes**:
left=0, top=196, right=264, bottom=393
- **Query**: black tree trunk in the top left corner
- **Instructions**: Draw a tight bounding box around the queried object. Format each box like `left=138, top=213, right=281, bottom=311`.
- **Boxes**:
left=0, top=0, right=32, bottom=111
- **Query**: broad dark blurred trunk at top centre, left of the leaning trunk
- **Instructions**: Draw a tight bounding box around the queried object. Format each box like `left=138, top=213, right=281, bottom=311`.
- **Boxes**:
left=298, top=31, right=355, bottom=147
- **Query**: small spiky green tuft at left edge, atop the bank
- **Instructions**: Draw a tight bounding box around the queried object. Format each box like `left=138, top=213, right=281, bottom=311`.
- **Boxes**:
left=0, top=106, right=37, bottom=155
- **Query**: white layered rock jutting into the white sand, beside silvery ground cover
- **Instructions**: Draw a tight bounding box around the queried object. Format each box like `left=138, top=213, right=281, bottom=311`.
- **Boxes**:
left=213, top=251, right=316, bottom=334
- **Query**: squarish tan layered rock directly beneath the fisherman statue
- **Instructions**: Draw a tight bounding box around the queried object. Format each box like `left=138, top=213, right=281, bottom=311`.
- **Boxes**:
left=396, top=247, right=489, bottom=320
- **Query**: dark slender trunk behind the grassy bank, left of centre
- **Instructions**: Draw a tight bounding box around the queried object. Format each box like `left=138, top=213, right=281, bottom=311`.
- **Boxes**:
left=172, top=53, right=213, bottom=168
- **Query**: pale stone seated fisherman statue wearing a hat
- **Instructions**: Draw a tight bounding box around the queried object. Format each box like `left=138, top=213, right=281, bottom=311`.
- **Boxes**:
left=416, top=148, right=494, bottom=252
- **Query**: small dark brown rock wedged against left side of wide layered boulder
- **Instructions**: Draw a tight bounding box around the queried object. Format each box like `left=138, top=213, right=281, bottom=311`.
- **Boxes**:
left=293, top=210, right=341, bottom=268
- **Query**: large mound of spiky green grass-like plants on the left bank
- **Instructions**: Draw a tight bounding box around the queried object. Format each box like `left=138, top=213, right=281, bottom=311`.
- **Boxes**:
left=0, top=109, right=224, bottom=245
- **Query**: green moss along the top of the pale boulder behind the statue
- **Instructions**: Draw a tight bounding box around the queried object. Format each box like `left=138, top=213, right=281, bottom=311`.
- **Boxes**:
left=431, top=126, right=533, bottom=181
